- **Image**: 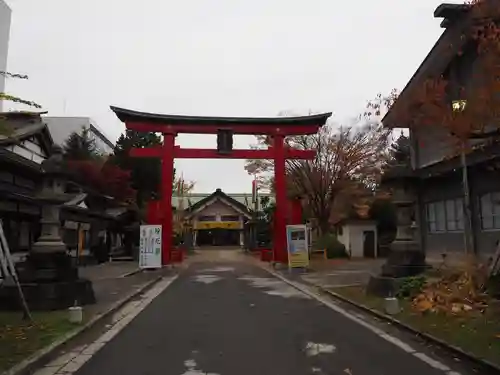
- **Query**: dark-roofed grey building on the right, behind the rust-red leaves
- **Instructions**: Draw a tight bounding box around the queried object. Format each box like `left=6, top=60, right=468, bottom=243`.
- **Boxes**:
left=383, top=4, right=500, bottom=257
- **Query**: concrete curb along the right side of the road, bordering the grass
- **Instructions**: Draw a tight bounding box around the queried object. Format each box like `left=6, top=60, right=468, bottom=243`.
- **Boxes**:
left=258, top=264, right=500, bottom=374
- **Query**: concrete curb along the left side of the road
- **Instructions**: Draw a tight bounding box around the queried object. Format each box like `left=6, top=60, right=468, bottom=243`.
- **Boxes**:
left=0, top=275, right=164, bottom=375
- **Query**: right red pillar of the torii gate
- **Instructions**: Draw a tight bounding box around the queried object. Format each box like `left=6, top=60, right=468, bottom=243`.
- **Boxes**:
left=273, top=135, right=288, bottom=263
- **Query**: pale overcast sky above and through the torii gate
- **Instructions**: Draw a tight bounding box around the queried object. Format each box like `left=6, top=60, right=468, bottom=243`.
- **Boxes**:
left=5, top=0, right=450, bottom=192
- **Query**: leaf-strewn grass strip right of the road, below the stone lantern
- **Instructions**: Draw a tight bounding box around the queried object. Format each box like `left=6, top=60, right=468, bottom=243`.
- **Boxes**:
left=331, top=287, right=500, bottom=365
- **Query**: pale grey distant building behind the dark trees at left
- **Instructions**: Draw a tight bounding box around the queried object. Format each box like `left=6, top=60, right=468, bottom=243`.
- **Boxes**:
left=42, top=116, right=115, bottom=155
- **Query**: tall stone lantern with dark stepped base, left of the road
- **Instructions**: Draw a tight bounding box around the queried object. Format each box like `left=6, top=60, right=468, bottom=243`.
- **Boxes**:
left=0, top=146, right=95, bottom=310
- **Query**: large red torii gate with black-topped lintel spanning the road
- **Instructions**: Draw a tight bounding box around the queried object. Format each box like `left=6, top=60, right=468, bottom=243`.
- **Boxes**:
left=111, top=106, right=332, bottom=264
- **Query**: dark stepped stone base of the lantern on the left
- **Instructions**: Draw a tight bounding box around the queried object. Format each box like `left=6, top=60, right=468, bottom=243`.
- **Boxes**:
left=0, top=252, right=96, bottom=311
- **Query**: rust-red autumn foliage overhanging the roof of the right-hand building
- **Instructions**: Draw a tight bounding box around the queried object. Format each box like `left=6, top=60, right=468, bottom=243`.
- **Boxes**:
left=393, top=0, right=500, bottom=145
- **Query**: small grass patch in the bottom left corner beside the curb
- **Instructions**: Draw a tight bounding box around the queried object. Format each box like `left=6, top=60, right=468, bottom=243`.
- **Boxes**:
left=0, top=311, right=77, bottom=372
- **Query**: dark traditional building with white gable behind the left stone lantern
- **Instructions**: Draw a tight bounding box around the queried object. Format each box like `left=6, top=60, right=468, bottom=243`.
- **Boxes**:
left=0, top=112, right=131, bottom=261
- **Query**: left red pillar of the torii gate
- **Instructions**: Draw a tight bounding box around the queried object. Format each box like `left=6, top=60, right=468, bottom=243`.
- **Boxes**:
left=161, top=133, right=175, bottom=265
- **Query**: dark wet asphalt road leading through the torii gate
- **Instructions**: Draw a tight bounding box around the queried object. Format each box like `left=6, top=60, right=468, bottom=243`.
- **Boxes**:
left=73, top=262, right=463, bottom=375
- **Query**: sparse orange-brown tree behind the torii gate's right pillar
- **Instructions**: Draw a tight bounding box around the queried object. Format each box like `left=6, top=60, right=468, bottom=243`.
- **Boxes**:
left=245, top=116, right=390, bottom=233
